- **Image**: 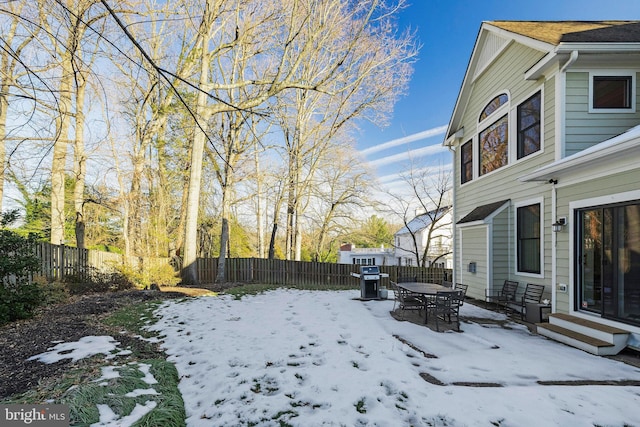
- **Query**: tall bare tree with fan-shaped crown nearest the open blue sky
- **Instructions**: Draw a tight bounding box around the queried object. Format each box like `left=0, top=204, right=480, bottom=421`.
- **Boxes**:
left=278, top=1, right=416, bottom=260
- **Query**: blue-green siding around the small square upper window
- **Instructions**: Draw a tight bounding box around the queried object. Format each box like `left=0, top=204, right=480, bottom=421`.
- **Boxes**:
left=564, top=71, right=640, bottom=156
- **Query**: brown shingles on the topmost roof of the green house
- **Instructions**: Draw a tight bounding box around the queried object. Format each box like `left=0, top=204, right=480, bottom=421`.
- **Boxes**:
left=488, top=21, right=640, bottom=46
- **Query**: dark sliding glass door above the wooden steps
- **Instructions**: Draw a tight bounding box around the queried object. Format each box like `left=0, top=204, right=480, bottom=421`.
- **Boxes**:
left=576, top=202, right=640, bottom=324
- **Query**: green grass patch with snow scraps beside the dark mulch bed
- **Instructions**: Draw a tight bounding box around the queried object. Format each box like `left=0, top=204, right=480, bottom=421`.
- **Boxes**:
left=2, top=301, right=186, bottom=427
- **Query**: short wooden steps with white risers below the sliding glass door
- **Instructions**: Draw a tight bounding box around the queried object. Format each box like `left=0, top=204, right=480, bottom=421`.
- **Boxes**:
left=536, top=313, right=630, bottom=356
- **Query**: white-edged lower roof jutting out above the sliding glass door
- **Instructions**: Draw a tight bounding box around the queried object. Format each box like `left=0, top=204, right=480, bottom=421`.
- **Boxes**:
left=519, top=125, right=640, bottom=182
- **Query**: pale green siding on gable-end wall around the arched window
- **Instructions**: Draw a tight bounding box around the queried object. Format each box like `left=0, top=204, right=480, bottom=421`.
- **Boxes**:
left=454, top=43, right=555, bottom=290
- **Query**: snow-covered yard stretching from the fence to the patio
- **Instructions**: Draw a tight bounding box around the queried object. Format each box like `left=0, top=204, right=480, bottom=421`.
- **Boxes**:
left=151, top=289, right=640, bottom=427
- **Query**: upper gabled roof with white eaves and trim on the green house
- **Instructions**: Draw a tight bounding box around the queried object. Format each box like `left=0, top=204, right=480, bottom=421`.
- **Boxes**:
left=443, top=21, right=640, bottom=146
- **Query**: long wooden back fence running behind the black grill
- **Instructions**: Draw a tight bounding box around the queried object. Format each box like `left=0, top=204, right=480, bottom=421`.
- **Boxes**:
left=197, top=258, right=451, bottom=288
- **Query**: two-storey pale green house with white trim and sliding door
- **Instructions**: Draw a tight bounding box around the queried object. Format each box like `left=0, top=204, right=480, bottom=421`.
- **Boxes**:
left=445, top=21, right=640, bottom=354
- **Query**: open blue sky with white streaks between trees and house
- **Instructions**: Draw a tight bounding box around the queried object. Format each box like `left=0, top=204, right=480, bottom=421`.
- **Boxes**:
left=357, top=0, right=640, bottom=189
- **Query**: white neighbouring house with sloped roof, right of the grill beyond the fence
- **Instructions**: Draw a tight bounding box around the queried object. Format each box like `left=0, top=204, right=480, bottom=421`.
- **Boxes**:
left=394, top=206, right=453, bottom=268
